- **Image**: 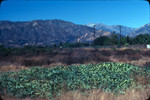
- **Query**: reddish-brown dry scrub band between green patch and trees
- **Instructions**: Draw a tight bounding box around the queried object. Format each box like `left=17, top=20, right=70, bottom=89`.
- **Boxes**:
left=0, top=48, right=150, bottom=67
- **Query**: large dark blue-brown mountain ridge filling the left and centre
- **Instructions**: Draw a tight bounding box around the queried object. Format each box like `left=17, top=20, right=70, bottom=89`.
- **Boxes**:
left=0, top=20, right=110, bottom=47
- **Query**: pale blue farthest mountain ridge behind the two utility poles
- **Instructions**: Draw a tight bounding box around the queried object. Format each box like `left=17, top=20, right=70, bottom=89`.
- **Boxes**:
left=87, top=23, right=136, bottom=36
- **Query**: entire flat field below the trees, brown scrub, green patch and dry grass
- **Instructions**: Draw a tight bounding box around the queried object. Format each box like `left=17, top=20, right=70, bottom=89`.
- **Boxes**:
left=0, top=46, right=150, bottom=100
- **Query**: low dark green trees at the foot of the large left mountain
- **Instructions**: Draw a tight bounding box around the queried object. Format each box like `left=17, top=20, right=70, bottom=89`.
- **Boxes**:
left=0, top=42, right=89, bottom=57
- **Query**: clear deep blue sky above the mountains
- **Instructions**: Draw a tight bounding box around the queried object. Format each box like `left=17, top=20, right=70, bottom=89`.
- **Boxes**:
left=0, top=0, right=150, bottom=28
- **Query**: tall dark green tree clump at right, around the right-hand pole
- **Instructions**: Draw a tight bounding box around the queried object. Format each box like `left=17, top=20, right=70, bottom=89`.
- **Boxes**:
left=93, top=32, right=150, bottom=46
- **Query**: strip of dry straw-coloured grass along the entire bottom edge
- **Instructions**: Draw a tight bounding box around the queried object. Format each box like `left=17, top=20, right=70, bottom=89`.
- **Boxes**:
left=2, top=89, right=150, bottom=100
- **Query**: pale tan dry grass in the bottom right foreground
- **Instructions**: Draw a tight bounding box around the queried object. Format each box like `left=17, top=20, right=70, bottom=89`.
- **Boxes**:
left=58, top=90, right=150, bottom=100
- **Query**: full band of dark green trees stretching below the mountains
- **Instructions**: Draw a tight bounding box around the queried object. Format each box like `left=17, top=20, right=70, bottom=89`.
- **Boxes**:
left=0, top=32, right=150, bottom=56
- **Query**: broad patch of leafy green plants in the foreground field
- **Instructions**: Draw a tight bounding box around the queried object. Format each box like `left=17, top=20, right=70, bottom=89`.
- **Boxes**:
left=0, top=62, right=149, bottom=97
